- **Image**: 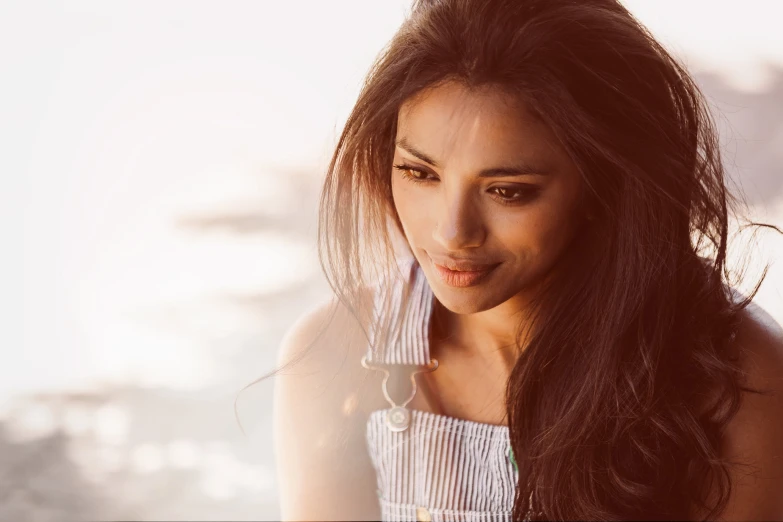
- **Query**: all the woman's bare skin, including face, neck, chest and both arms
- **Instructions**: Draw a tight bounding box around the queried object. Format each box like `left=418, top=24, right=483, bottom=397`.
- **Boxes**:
left=274, top=75, right=783, bottom=520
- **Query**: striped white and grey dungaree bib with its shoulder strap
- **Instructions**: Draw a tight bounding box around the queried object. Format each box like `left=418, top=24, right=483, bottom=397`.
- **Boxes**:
left=366, top=261, right=518, bottom=521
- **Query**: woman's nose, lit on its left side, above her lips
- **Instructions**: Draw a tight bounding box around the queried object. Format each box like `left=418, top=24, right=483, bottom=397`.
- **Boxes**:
left=432, top=189, right=486, bottom=252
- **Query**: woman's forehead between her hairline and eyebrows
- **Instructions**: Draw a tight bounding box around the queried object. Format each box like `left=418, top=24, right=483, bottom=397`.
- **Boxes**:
left=397, top=82, right=564, bottom=163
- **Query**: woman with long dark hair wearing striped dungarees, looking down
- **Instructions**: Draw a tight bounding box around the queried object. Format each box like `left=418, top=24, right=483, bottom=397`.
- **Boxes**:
left=275, top=0, right=783, bottom=520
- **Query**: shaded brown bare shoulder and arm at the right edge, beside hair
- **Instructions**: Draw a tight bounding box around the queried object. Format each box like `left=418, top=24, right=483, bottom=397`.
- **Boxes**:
left=723, top=303, right=783, bottom=520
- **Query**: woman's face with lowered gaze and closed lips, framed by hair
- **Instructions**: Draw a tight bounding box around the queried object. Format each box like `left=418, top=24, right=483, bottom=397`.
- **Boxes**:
left=391, top=78, right=583, bottom=314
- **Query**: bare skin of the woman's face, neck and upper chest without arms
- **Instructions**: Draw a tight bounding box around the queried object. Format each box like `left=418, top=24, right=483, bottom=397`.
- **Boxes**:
left=391, top=82, right=585, bottom=425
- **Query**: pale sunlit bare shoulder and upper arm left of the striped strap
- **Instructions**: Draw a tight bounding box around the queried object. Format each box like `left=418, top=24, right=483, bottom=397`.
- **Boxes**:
left=274, top=290, right=380, bottom=520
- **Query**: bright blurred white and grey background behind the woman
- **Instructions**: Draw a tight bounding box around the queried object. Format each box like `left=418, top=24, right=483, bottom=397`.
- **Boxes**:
left=6, top=0, right=783, bottom=521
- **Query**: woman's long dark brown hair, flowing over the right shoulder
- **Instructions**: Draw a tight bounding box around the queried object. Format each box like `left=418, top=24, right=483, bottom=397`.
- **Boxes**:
left=268, top=0, right=780, bottom=520
